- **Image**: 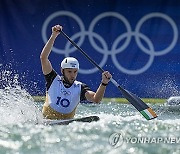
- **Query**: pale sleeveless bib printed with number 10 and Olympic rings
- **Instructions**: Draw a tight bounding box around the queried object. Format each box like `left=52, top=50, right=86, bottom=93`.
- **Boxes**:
left=47, top=75, right=82, bottom=114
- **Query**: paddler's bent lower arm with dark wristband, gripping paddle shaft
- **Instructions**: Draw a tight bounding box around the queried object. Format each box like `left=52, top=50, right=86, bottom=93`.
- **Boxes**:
left=85, top=71, right=112, bottom=103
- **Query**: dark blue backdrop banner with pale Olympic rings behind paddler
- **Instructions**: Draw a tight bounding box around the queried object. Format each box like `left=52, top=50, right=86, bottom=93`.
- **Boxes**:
left=0, top=0, right=180, bottom=98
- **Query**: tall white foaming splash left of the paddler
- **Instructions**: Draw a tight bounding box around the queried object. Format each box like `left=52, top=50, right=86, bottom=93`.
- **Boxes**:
left=0, top=71, right=42, bottom=125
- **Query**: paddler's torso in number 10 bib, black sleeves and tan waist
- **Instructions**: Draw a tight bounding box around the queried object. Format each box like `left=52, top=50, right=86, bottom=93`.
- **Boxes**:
left=42, top=70, right=90, bottom=119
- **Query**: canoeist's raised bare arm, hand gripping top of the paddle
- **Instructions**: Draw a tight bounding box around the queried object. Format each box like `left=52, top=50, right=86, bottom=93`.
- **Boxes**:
left=40, top=25, right=62, bottom=75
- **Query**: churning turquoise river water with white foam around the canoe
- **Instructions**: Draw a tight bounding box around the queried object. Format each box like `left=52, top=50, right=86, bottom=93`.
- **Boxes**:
left=0, top=71, right=180, bottom=154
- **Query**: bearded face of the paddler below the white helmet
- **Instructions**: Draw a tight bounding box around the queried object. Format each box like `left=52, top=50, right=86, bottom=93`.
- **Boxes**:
left=61, top=68, right=78, bottom=84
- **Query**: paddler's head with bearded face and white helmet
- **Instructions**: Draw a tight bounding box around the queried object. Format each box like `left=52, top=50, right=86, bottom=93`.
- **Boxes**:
left=61, top=57, right=79, bottom=84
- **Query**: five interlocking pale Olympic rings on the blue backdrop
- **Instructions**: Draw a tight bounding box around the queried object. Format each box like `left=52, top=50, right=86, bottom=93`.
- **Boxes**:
left=42, top=11, right=178, bottom=75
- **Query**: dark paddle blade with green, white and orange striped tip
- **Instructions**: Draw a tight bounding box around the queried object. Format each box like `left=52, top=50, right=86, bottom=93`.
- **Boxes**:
left=118, top=86, right=157, bottom=120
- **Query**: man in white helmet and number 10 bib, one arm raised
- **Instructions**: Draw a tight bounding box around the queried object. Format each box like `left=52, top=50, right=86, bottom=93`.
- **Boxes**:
left=40, top=25, right=112, bottom=120
